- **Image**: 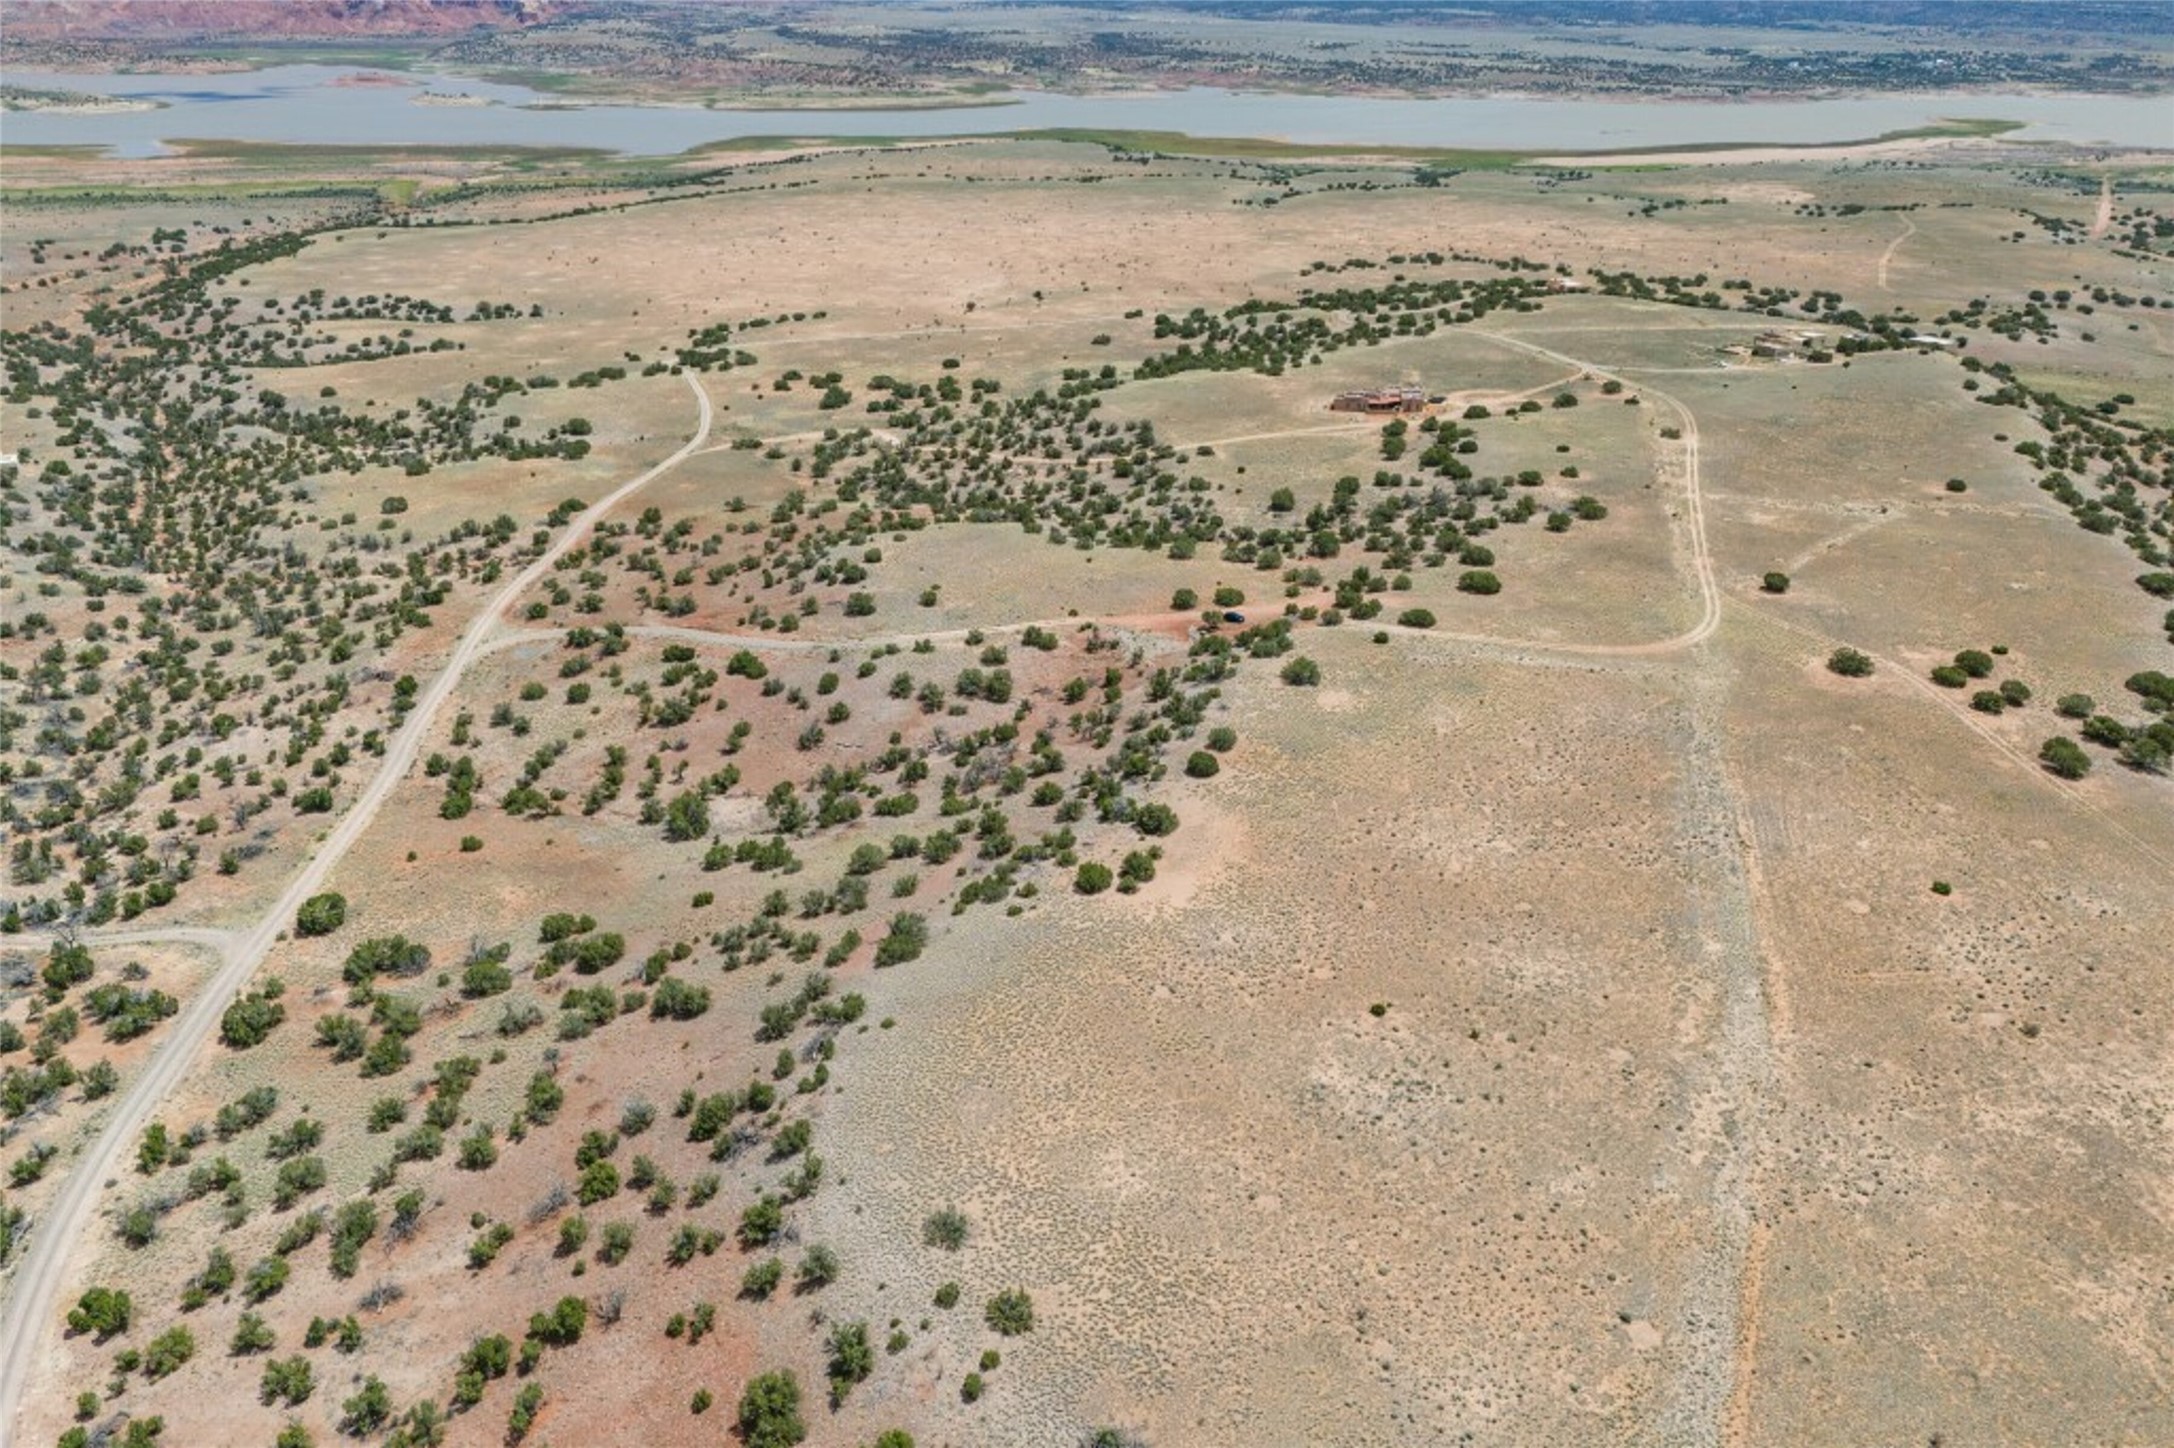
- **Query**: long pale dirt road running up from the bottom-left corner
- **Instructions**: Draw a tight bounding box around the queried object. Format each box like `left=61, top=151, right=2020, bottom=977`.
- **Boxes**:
left=0, top=372, right=711, bottom=1441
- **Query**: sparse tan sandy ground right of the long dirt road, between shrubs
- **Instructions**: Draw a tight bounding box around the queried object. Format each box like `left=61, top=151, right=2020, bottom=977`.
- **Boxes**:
left=11, top=135, right=2174, bottom=1448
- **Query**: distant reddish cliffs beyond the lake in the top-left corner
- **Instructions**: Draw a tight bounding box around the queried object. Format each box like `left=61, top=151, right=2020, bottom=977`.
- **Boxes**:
left=7, top=0, right=570, bottom=41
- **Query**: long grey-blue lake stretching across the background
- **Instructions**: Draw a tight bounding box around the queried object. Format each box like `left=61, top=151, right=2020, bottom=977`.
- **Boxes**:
left=0, top=65, right=2174, bottom=157
